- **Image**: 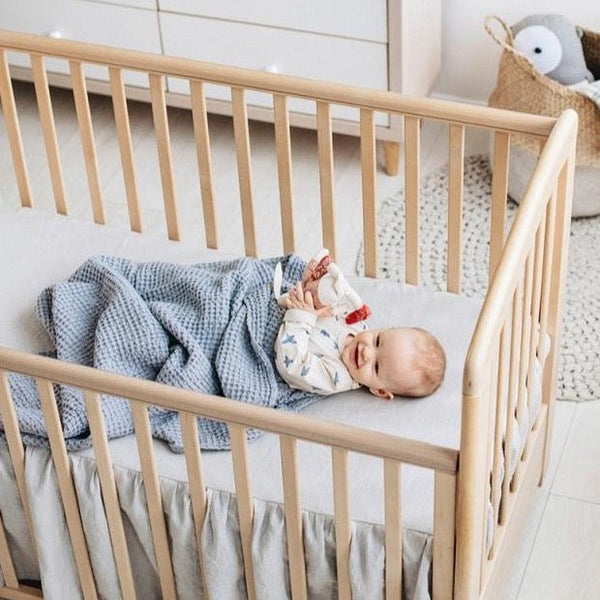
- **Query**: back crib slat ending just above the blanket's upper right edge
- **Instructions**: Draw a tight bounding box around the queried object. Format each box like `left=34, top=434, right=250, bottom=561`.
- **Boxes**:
left=273, top=94, right=296, bottom=254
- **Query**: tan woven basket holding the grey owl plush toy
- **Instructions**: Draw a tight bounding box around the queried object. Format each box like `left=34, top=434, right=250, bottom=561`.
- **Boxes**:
left=485, top=17, right=600, bottom=167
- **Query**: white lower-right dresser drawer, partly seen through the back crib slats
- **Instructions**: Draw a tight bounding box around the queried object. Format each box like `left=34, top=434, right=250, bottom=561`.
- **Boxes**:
left=160, top=13, right=388, bottom=123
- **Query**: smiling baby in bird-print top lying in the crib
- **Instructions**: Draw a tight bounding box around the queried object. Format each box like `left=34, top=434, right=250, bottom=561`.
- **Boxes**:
left=275, top=251, right=446, bottom=400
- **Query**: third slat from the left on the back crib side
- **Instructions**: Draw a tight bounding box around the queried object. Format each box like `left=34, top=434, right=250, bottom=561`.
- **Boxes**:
left=69, top=60, right=105, bottom=225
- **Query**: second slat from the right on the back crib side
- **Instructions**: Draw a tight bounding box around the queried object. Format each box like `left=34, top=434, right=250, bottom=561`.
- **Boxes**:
left=447, top=125, right=465, bottom=294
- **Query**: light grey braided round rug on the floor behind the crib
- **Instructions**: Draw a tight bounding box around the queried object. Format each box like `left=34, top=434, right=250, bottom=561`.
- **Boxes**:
left=356, top=155, right=600, bottom=400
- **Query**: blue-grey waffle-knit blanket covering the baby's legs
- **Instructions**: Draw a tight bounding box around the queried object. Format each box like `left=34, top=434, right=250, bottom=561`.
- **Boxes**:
left=10, top=255, right=317, bottom=452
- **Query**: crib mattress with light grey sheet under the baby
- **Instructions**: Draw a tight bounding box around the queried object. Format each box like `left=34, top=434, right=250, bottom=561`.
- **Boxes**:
left=0, top=209, right=480, bottom=533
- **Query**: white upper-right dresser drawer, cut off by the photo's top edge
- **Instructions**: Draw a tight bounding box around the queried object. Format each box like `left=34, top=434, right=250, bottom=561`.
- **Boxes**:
left=158, top=0, right=386, bottom=43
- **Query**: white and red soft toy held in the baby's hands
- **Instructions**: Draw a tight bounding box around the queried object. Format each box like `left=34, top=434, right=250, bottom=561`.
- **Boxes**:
left=273, top=248, right=371, bottom=325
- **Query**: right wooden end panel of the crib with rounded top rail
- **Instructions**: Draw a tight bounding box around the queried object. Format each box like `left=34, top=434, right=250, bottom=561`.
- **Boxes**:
left=455, top=113, right=577, bottom=598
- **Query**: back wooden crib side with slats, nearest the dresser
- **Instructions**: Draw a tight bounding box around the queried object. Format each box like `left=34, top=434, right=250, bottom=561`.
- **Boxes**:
left=0, top=32, right=554, bottom=284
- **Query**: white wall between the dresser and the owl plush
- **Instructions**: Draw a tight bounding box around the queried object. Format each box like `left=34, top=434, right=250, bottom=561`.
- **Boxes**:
left=434, top=0, right=600, bottom=104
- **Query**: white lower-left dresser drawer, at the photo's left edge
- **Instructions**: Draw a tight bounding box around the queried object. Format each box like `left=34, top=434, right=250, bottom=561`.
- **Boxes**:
left=0, top=0, right=161, bottom=87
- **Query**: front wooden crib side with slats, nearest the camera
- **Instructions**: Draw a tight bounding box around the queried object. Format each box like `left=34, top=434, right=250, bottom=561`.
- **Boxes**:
left=0, top=349, right=458, bottom=600
